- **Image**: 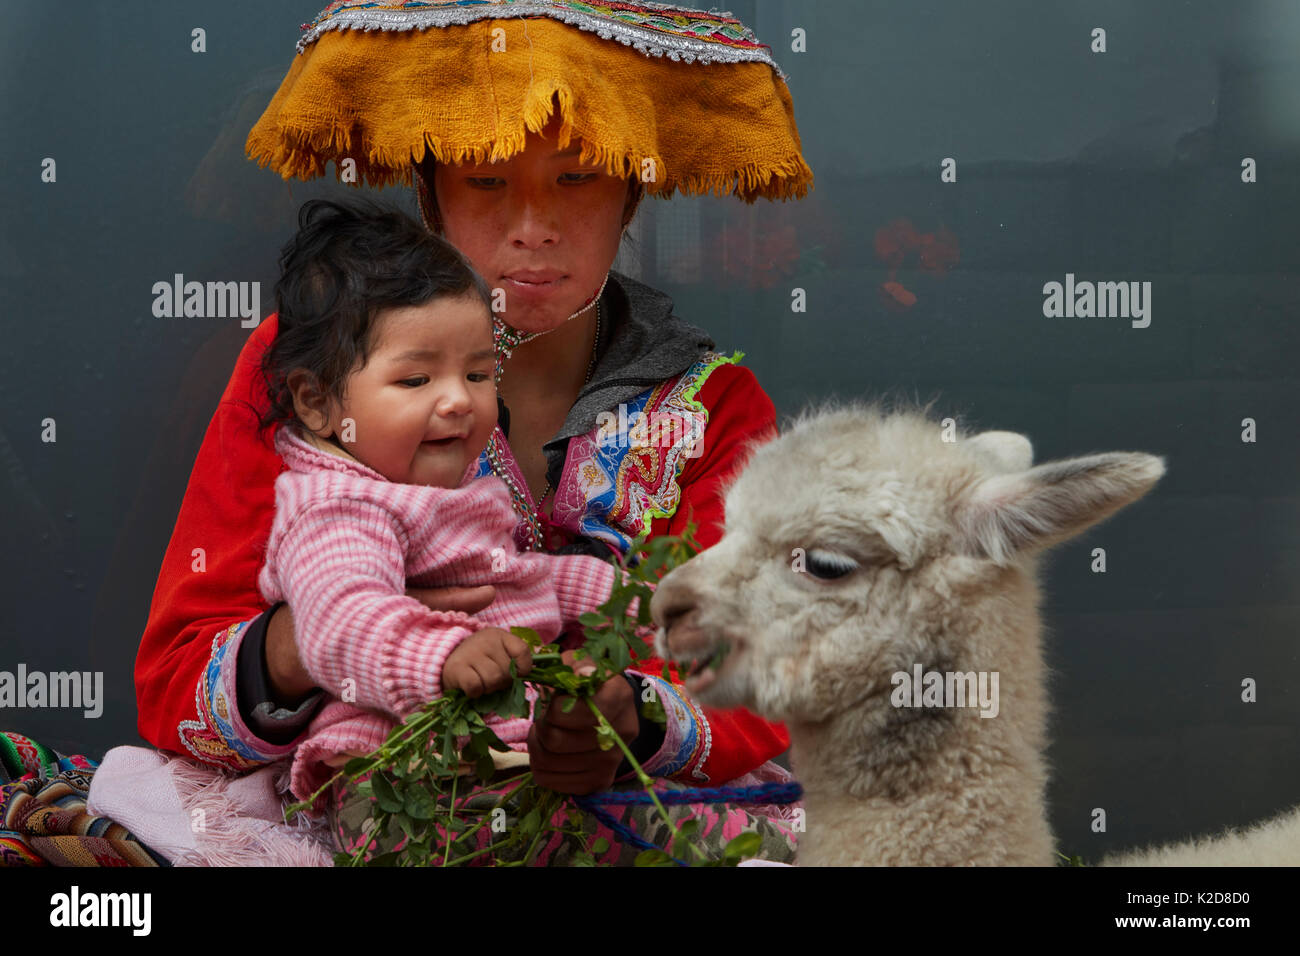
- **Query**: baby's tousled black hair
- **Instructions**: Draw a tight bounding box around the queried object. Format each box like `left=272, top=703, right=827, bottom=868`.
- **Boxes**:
left=257, top=199, right=491, bottom=442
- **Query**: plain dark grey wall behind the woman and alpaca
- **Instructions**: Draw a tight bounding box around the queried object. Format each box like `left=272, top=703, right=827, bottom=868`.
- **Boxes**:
left=0, top=0, right=1300, bottom=857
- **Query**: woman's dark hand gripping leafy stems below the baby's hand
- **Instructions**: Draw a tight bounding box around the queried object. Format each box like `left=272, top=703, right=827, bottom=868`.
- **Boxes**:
left=528, top=650, right=640, bottom=796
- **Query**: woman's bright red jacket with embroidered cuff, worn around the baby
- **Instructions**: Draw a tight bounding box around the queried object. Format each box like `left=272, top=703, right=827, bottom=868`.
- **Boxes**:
left=135, top=277, right=789, bottom=783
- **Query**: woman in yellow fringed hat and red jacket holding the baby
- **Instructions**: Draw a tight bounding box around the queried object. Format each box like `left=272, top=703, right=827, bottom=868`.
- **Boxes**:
left=91, top=1, right=811, bottom=868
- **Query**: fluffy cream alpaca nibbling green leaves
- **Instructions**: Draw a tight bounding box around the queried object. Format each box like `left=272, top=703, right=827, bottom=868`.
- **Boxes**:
left=651, top=405, right=1300, bottom=865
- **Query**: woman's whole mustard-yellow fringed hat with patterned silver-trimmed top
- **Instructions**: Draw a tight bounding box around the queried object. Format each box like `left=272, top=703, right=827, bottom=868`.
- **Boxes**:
left=246, top=0, right=813, bottom=203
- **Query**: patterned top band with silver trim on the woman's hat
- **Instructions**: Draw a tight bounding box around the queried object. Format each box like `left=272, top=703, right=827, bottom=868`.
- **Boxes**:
left=296, top=0, right=789, bottom=82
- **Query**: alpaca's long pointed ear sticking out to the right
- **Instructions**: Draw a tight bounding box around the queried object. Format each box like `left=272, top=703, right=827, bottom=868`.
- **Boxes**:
left=956, top=451, right=1165, bottom=566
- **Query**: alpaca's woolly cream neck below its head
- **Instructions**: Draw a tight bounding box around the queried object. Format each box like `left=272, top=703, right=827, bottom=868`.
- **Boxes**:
left=789, top=704, right=1054, bottom=866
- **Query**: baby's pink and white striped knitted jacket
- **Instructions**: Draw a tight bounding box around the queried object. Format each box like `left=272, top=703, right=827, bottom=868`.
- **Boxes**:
left=257, top=428, right=616, bottom=800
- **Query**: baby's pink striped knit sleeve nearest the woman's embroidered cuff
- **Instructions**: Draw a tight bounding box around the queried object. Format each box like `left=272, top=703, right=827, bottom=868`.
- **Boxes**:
left=273, top=498, right=486, bottom=718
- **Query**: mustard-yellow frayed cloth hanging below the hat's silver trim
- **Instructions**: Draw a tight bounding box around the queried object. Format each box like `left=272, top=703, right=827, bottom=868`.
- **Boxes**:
left=246, top=21, right=813, bottom=203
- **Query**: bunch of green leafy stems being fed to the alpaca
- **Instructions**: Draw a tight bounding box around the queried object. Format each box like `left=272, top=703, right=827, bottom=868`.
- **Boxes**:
left=286, top=524, right=759, bottom=866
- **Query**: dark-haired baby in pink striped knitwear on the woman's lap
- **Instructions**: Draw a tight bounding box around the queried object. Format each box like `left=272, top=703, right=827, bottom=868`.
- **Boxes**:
left=257, top=200, right=616, bottom=800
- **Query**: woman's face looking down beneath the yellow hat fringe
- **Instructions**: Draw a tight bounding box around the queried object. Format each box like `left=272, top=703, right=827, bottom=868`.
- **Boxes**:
left=433, top=126, right=628, bottom=332
